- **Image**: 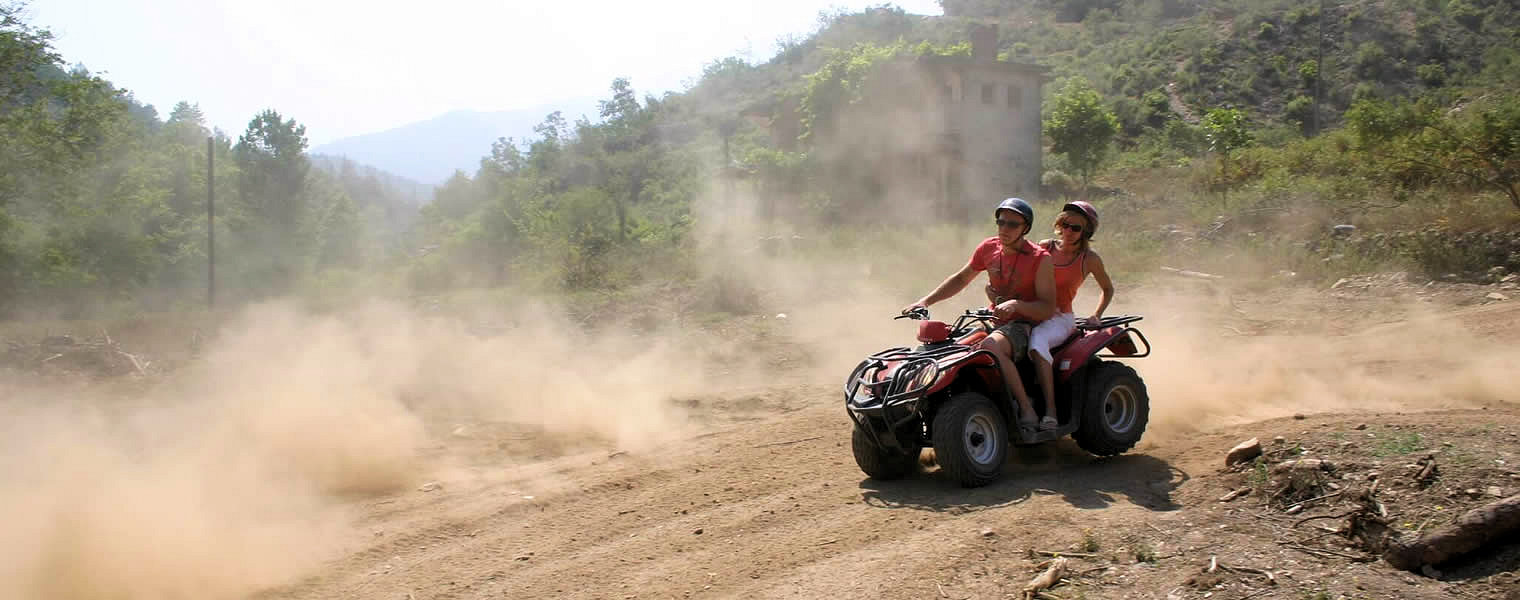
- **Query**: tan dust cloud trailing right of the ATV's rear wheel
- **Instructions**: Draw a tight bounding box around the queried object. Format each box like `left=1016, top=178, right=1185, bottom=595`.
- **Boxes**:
left=1134, top=286, right=1520, bottom=436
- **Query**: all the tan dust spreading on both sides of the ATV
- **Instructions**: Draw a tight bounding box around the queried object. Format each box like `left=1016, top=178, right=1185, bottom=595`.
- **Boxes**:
left=0, top=186, right=1520, bottom=600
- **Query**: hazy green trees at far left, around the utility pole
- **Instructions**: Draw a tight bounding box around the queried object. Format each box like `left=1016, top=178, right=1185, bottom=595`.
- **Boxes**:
left=0, top=5, right=427, bottom=316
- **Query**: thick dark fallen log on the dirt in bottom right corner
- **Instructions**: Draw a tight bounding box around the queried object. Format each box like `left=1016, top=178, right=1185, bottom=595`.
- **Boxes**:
left=1383, top=494, right=1520, bottom=573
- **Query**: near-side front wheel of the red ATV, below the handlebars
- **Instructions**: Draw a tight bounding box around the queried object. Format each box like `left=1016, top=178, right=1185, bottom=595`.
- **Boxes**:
left=932, top=392, right=1008, bottom=488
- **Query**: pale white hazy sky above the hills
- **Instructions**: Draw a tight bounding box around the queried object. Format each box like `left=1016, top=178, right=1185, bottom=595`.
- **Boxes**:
left=26, top=0, right=941, bottom=146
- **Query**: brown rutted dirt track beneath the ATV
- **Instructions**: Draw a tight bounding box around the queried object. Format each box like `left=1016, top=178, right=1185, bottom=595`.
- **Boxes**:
left=258, top=297, right=1520, bottom=600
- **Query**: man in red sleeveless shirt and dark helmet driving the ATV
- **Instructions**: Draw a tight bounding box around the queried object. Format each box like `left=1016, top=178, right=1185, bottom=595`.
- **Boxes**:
left=903, top=197, right=1058, bottom=440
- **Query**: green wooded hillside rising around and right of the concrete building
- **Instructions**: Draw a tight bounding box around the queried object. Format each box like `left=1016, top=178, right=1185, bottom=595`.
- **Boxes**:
left=410, top=0, right=1520, bottom=296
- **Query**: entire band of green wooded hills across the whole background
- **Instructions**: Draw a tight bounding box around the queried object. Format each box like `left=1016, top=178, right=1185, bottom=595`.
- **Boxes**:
left=0, top=0, right=1520, bottom=316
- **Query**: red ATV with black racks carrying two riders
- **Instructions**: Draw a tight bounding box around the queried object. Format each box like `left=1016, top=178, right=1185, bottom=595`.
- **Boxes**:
left=845, top=308, right=1151, bottom=488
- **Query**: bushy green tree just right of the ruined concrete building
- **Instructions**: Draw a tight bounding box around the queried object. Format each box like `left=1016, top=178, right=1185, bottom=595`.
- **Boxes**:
left=1044, top=79, right=1119, bottom=188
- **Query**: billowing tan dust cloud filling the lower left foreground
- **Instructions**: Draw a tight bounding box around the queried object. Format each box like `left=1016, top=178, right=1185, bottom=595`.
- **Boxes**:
left=0, top=297, right=723, bottom=600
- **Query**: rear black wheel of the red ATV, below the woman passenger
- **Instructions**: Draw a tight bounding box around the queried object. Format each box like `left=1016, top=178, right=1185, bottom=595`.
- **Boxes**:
left=1072, top=362, right=1151, bottom=456
